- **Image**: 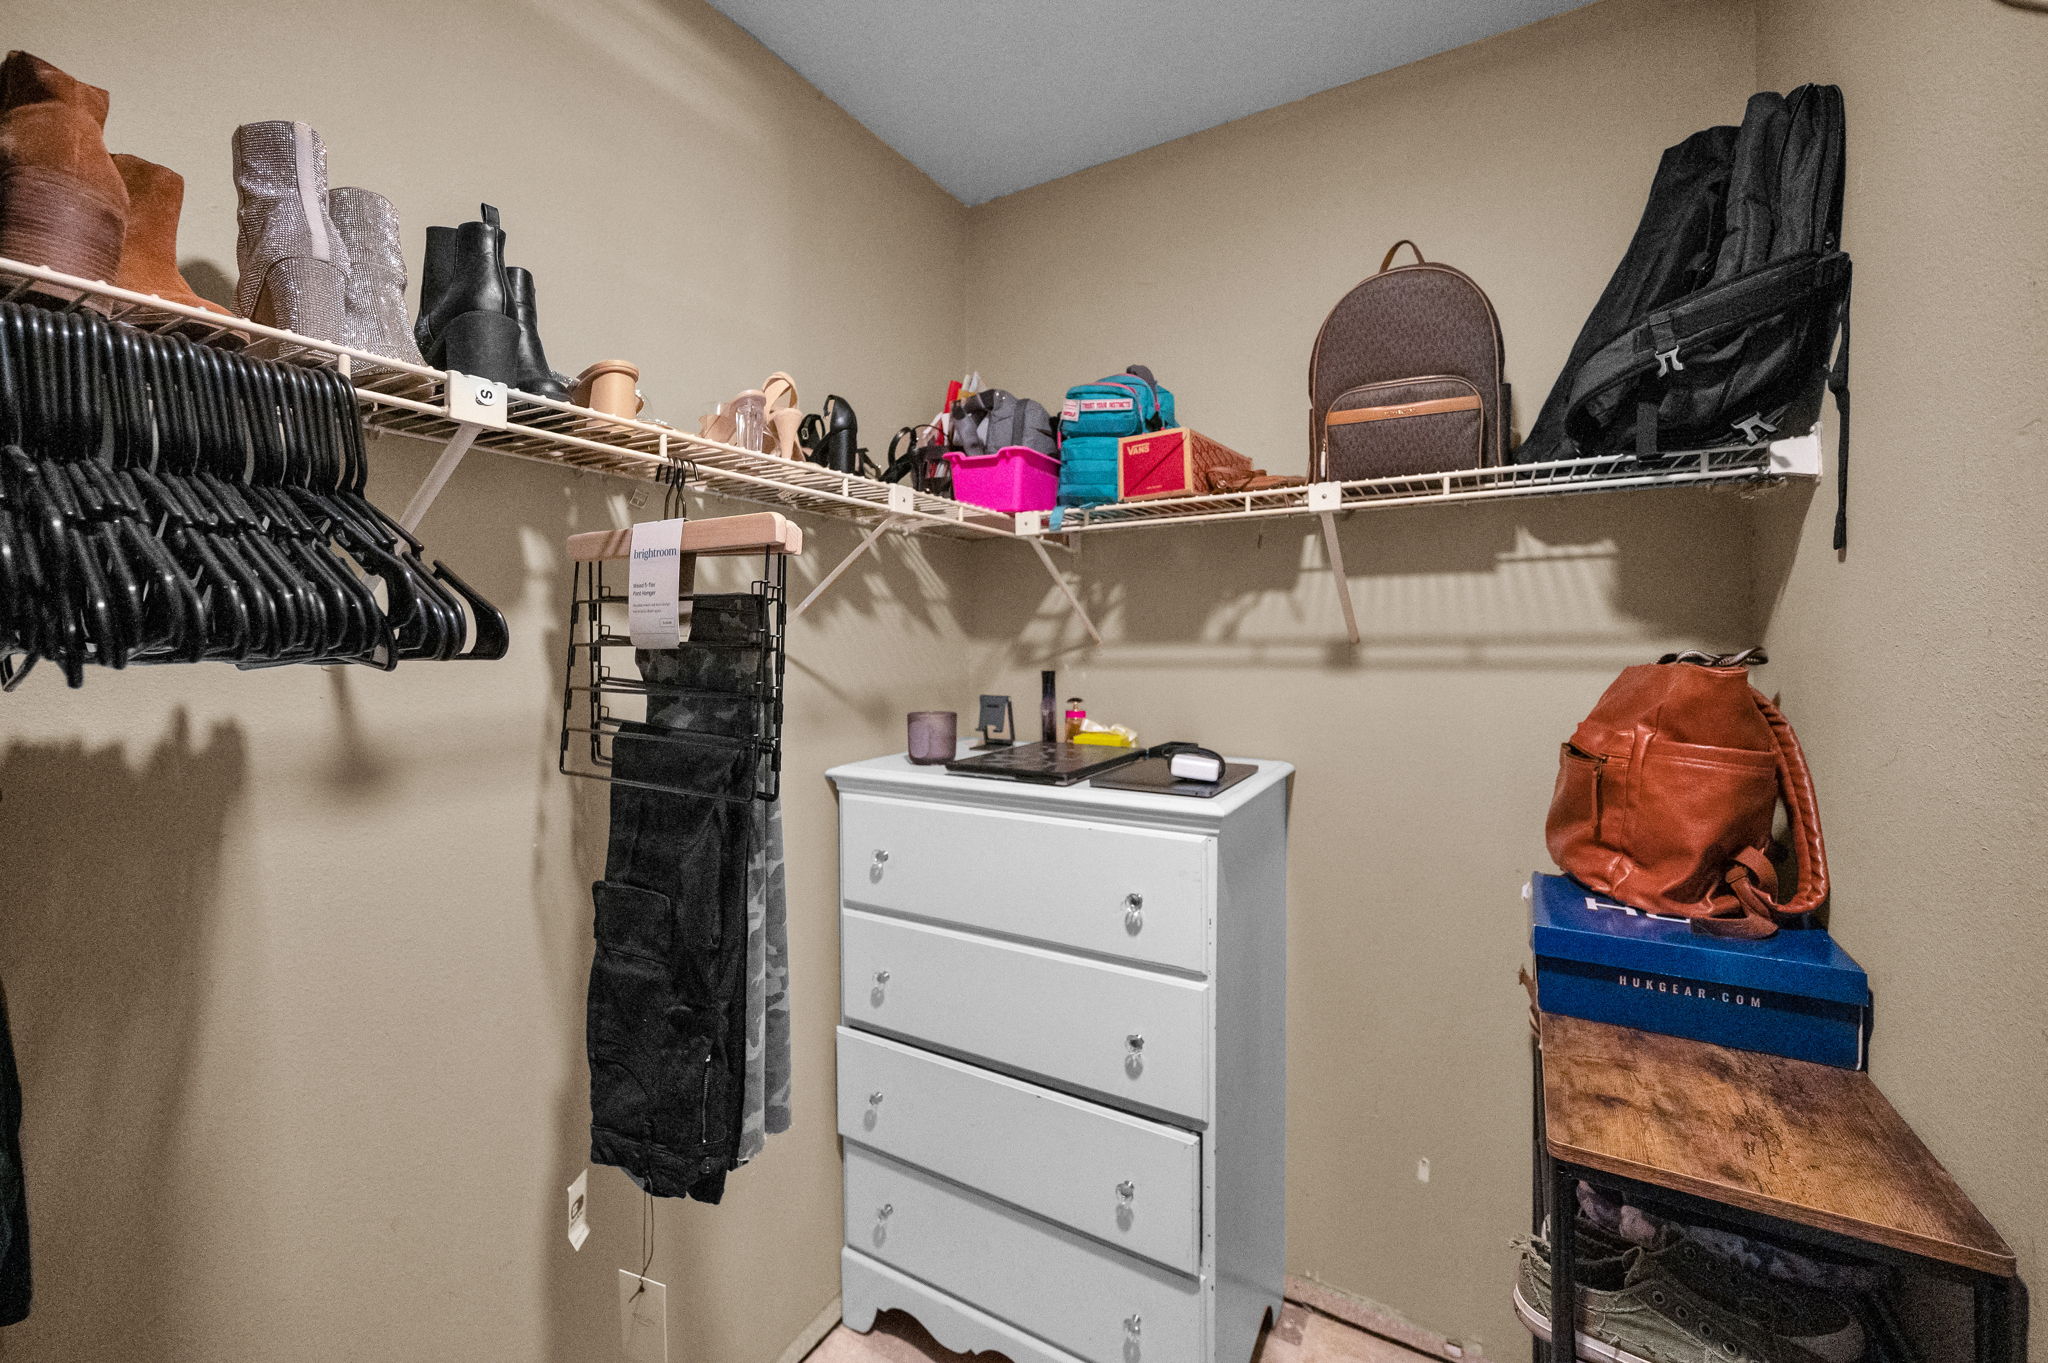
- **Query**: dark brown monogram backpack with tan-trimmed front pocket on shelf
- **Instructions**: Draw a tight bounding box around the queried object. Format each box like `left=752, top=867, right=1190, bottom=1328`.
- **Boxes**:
left=1309, top=241, right=1509, bottom=483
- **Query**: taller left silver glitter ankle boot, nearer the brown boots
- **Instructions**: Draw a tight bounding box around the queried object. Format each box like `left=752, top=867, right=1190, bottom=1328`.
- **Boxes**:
left=236, top=119, right=348, bottom=342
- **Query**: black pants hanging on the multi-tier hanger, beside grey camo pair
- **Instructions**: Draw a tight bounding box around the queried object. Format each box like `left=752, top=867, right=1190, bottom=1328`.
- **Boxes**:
left=586, top=596, right=762, bottom=1201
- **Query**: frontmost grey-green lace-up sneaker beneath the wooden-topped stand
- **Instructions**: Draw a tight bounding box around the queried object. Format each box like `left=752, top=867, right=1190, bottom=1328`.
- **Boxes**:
left=1516, top=1238, right=1821, bottom=1363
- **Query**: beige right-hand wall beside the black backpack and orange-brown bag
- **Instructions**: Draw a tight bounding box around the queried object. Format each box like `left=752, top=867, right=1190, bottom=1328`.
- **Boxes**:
left=1757, top=0, right=2048, bottom=1355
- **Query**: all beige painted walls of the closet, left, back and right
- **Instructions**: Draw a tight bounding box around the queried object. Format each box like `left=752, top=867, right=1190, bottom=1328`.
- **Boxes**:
left=0, top=0, right=2048, bottom=1363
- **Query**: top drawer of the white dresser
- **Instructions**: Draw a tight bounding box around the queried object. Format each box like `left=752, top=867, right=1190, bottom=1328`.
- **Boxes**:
left=840, top=796, right=1210, bottom=974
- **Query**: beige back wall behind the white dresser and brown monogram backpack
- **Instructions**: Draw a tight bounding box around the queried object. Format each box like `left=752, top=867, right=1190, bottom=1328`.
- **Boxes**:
left=967, top=0, right=1759, bottom=1357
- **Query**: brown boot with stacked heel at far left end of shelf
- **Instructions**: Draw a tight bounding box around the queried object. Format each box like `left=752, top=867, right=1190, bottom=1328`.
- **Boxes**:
left=0, top=51, right=127, bottom=293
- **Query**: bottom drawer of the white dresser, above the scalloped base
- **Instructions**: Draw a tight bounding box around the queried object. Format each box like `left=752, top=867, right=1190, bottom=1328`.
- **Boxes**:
left=846, top=1146, right=1202, bottom=1363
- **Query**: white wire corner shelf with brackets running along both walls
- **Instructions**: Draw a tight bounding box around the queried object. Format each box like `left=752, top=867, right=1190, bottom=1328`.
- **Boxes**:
left=0, top=258, right=1821, bottom=643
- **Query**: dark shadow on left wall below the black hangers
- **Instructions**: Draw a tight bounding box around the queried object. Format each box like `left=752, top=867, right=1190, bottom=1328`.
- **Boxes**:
left=0, top=710, right=248, bottom=1359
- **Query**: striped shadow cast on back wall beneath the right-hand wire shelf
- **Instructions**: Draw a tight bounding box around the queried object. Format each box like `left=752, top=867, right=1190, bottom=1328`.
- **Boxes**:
left=973, top=489, right=1810, bottom=669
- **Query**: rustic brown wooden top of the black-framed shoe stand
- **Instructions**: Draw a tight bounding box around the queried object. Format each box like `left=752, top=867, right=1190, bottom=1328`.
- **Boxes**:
left=1542, top=1013, right=2017, bottom=1277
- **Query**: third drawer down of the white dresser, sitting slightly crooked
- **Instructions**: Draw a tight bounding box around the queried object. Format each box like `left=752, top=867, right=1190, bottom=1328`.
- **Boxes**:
left=840, top=1027, right=1202, bottom=1273
